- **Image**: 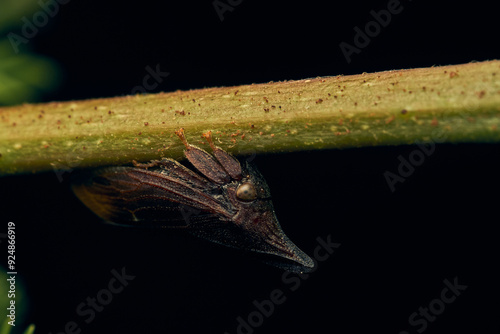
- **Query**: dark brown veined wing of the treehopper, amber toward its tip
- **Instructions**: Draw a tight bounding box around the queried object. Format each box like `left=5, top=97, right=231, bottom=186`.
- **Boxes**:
left=72, top=164, right=234, bottom=227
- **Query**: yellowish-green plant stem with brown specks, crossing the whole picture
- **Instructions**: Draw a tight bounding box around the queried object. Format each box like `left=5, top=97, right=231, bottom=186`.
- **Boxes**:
left=0, top=61, right=500, bottom=175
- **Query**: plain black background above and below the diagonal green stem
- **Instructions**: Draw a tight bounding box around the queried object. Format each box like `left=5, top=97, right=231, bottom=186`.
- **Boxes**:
left=0, top=0, right=500, bottom=334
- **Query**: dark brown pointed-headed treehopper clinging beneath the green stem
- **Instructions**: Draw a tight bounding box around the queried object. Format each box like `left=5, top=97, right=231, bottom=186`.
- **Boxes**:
left=73, top=129, right=314, bottom=272
